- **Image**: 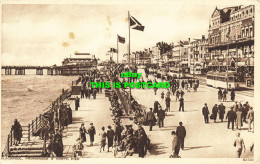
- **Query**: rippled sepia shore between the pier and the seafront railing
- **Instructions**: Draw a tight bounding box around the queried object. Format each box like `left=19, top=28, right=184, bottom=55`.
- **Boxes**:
left=1, top=75, right=77, bottom=150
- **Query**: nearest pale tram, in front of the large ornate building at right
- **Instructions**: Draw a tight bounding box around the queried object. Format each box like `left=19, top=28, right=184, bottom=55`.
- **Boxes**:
left=207, top=71, right=240, bottom=89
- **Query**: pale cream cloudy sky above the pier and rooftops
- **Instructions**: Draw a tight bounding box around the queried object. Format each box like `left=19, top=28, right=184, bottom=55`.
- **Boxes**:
left=1, top=3, right=254, bottom=66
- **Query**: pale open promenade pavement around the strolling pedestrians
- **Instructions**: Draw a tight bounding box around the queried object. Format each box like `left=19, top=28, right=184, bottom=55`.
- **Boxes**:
left=63, top=70, right=254, bottom=158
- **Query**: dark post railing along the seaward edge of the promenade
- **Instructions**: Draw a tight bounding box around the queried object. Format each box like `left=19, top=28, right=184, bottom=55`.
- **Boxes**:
left=2, top=87, right=73, bottom=157
